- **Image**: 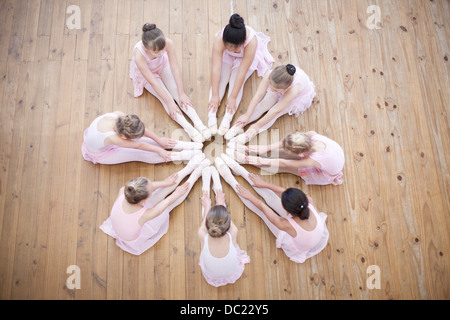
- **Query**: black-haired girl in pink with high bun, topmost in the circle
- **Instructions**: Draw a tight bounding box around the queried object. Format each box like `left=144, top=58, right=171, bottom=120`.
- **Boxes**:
left=208, top=14, right=274, bottom=136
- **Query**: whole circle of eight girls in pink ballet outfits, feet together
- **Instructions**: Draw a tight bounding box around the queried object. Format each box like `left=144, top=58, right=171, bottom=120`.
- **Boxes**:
left=82, top=14, right=344, bottom=287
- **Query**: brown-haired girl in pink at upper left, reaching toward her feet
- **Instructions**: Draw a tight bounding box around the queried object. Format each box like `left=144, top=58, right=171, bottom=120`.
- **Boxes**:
left=130, top=23, right=211, bottom=142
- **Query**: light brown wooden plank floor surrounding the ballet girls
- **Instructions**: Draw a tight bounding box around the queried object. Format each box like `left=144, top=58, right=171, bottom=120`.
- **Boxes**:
left=0, top=0, right=450, bottom=300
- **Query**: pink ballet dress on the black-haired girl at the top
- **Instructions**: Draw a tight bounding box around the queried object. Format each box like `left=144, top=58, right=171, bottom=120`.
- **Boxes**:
left=216, top=26, right=275, bottom=77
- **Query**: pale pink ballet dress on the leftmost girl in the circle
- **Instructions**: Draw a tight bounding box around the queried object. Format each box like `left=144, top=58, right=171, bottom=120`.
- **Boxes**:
left=81, top=113, right=120, bottom=164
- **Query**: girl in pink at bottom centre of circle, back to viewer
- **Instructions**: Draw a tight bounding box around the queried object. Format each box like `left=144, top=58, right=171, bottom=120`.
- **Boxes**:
left=198, top=167, right=250, bottom=287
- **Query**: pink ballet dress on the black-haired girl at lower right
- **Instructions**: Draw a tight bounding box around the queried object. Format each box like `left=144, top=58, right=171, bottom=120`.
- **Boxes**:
left=276, top=204, right=329, bottom=263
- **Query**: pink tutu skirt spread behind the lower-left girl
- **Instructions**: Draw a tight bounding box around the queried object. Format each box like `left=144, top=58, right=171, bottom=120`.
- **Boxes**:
left=100, top=212, right=169, bottom=255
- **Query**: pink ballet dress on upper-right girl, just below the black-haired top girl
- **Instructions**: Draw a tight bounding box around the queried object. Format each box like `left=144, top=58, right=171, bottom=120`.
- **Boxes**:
left=267, top=67, right=316, bottom=117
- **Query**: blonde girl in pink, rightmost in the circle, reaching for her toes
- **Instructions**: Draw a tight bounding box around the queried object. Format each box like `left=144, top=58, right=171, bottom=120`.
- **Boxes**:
left=232, top=131, right=345, bottom=185
